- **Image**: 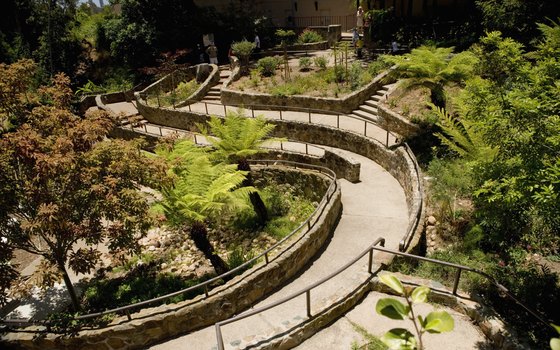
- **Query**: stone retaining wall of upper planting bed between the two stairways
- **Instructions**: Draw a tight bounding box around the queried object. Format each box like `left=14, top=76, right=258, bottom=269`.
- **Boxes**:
left=221, top=72, right=387, bottom=113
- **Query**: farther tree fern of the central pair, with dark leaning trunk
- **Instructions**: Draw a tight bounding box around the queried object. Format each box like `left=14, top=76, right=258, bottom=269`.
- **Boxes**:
left=198, top=110, right=279, bottom=224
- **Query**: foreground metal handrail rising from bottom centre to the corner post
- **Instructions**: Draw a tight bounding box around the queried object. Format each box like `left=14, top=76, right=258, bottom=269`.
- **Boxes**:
left=215, top=238, right=385, bottom=350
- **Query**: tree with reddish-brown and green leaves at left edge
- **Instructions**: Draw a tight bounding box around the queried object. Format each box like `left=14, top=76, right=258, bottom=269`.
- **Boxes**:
left=0, top=75, right=162, bottom=309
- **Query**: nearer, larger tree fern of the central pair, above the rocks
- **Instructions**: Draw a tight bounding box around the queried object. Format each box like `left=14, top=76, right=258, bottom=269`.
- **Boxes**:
left=158, top=140, right=255, bottom=274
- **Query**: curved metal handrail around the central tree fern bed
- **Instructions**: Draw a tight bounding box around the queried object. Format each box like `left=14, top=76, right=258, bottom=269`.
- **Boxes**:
left=0, top=160, right=338, bottom=326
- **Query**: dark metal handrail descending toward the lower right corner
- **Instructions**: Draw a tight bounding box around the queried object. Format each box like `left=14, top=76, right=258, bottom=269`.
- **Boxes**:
left=372, top=247, right=551, bottom=327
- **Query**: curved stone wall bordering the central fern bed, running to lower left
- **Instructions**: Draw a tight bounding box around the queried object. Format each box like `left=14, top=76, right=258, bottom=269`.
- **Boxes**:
left=2, top=167, right=342, bottom=350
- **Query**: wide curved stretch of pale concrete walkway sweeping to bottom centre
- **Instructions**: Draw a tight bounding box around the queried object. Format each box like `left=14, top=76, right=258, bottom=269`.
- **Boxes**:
left=151, top=151, right=408, bottom=350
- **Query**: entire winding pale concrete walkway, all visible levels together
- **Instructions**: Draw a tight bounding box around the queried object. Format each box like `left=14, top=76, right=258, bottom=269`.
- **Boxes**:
left=103, top=61, right=486, bottom=350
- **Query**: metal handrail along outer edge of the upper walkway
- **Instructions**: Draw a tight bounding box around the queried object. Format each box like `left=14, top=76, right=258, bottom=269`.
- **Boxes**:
left=144, top=99, right=398, bottom=148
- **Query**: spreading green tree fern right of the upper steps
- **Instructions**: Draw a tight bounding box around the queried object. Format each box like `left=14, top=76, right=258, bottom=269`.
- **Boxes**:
left=383, top=46, right=478, bottom=108
